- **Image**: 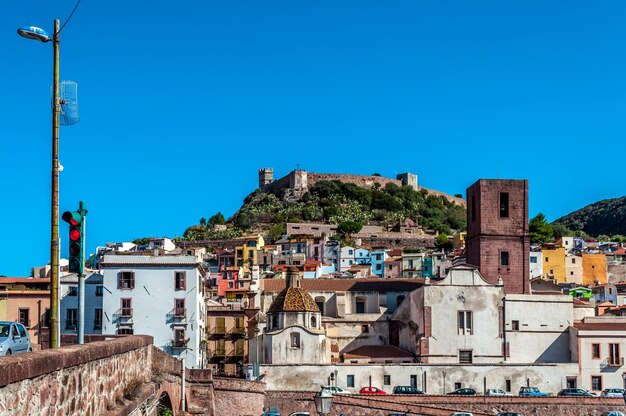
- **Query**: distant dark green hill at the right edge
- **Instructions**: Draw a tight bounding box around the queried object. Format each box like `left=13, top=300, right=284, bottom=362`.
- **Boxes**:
left=553, top=196, right=626, bottom=237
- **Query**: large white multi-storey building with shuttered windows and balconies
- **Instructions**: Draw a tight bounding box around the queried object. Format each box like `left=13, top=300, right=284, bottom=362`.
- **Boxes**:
left=102, top=255, right=205, bottom=368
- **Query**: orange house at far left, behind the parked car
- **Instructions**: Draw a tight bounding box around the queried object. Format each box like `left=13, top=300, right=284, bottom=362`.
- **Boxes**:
left=0, top=277, right=50, bottom=348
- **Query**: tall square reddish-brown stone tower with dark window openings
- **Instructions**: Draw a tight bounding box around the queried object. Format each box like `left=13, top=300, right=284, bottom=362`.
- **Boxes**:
left=466, top=179, right=530, bottom=293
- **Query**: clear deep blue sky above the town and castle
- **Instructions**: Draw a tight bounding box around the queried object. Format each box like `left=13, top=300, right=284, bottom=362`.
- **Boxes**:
left=0, top=0, right=626, bottom=276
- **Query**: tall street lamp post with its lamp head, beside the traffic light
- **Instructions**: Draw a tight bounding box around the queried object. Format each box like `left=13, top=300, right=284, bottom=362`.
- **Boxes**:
left=17, top=19, right=61, bottom=348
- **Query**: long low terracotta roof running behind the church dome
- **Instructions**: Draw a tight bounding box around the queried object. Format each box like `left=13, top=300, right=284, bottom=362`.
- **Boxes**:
left=261, top=277, right=424, bottom=293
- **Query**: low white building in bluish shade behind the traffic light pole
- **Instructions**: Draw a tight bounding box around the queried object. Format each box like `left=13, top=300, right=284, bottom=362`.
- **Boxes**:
left=59, top=273, right=104, bottom=334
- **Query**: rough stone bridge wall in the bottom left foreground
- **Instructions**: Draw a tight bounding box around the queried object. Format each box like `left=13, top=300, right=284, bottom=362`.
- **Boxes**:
left=0, top=336, right=153, bottom=416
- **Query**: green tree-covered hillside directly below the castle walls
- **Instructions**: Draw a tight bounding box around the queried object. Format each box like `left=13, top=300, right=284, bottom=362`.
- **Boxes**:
left=183, top=174, right=466, bottom=240
